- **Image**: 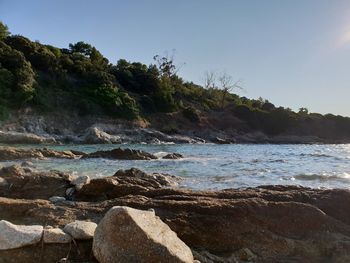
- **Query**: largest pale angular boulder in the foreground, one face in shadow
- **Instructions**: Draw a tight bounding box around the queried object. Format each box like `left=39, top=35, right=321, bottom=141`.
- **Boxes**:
left=93, top=206, right=193, bottom=263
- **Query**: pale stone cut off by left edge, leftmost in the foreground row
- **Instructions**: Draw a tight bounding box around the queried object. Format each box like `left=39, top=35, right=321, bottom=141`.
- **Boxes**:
left=0, top=220, right=43, bottom=250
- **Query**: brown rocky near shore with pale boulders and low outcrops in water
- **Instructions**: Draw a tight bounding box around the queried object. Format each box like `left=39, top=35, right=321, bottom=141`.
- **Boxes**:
left=0, top=148, right=350, bottom=263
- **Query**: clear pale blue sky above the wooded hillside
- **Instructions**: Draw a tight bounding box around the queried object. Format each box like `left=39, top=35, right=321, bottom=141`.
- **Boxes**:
left=0, top=0, right=350, bottom=116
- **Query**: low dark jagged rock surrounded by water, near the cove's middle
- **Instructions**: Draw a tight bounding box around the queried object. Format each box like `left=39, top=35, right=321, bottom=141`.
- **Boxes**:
left=83, top=148, right=157, bottom=160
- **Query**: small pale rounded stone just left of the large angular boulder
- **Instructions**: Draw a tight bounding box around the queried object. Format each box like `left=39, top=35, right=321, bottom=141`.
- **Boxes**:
left=63, top=220, right=97, bottom=240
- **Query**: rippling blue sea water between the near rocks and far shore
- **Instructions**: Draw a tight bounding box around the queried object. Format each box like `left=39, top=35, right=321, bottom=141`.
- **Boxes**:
left=0, top=144, right=350, bottom=189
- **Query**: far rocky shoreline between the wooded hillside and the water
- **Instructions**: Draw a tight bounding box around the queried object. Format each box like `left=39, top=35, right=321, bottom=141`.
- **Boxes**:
left=0, top=113, right=350, bottom=144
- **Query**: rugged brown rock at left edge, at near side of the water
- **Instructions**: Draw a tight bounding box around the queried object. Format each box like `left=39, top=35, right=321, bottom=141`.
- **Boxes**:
left=0, top=165, right=70, bottom=199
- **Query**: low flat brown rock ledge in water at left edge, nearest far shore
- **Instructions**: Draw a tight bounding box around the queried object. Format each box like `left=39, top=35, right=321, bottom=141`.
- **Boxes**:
left=0, top=147, right=77, bottom=161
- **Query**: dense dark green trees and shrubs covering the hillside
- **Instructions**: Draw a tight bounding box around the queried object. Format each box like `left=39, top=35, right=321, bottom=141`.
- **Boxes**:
left=0, top=22, right=350, bottom=139
